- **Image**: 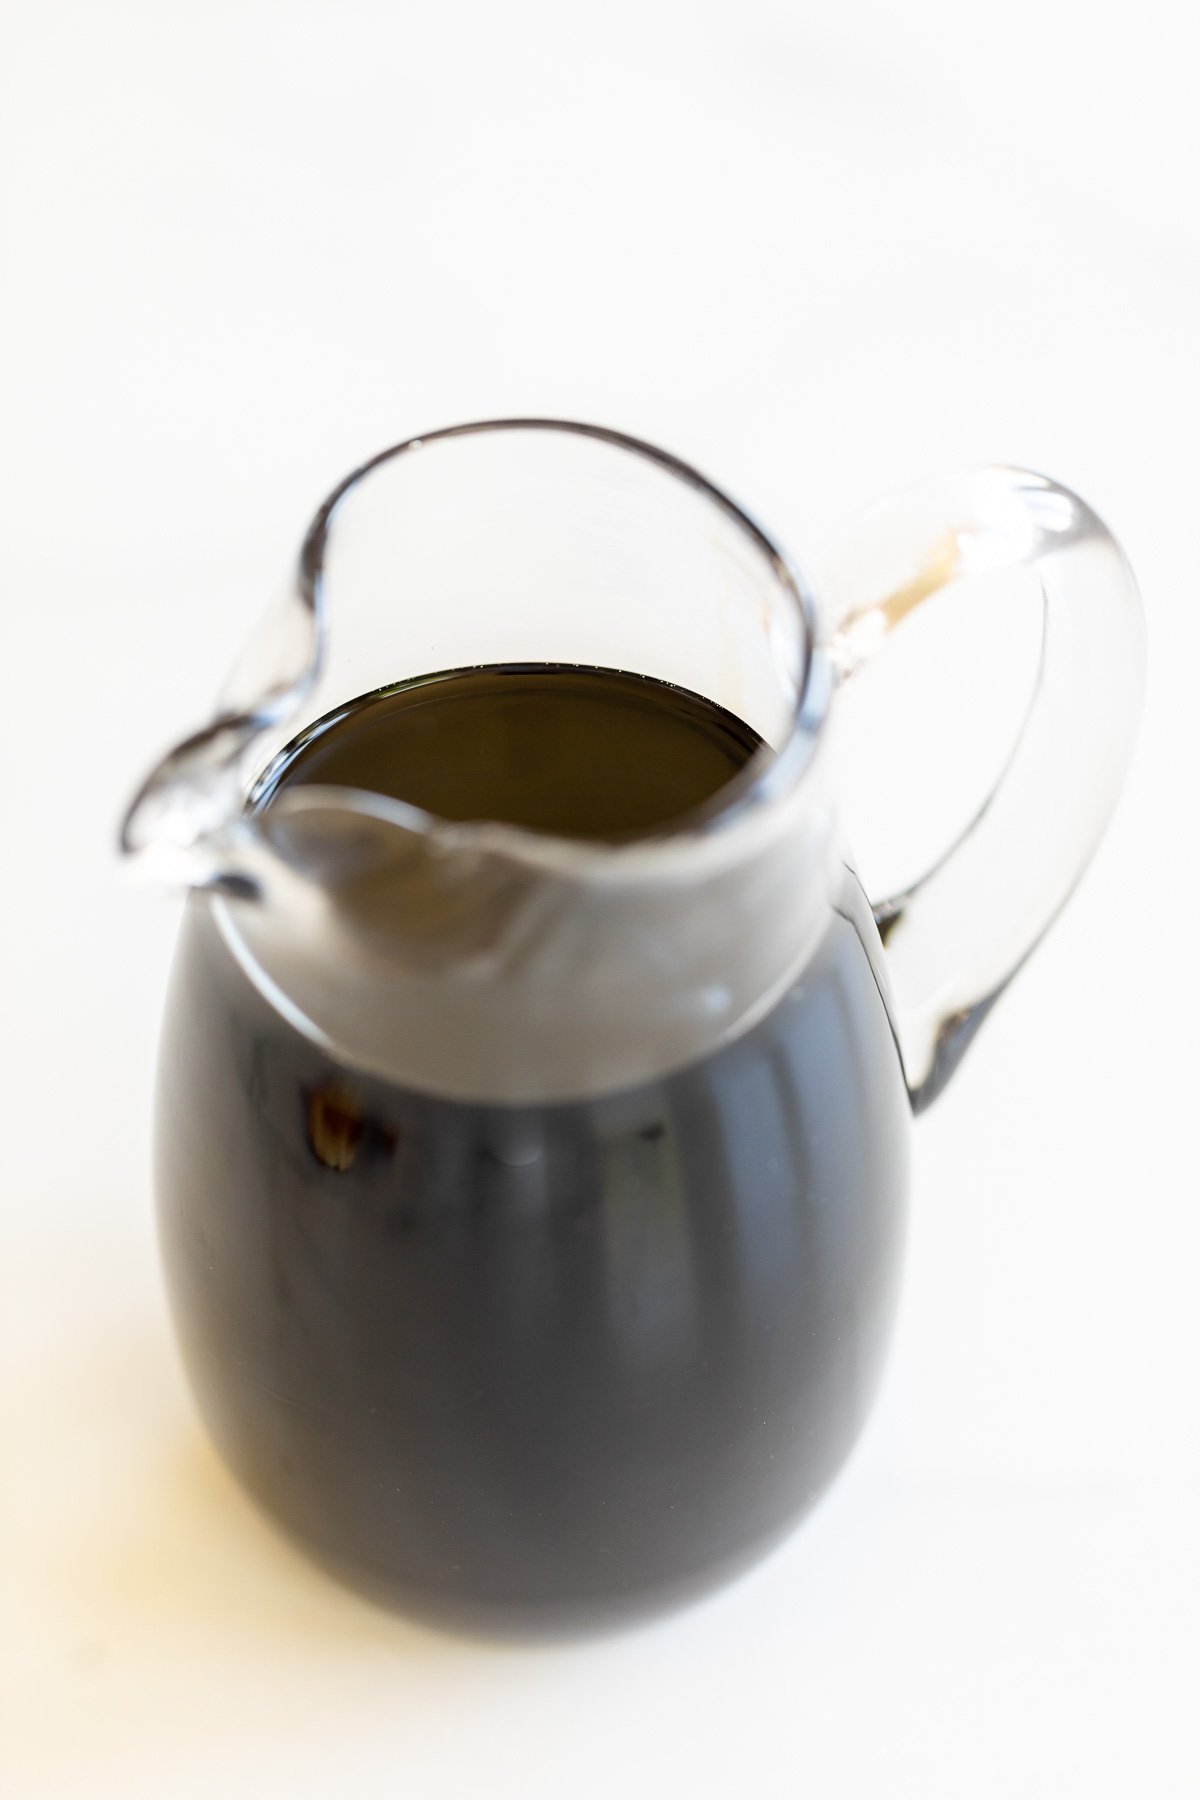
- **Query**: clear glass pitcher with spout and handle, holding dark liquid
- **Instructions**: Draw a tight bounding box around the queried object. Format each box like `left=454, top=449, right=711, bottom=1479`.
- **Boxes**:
left=122, top=419, right=1142, bottom=1633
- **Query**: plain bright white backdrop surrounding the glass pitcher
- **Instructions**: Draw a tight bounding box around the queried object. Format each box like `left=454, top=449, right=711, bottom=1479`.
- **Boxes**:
left=0, top=0, right=1200, bottom=1800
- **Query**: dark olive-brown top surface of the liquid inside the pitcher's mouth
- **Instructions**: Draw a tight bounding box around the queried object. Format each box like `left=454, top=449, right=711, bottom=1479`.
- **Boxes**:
left=257, top=664, right=763, bottom=842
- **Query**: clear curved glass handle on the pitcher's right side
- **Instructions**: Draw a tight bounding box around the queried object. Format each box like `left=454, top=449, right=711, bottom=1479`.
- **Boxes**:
left=824, top=468, right=1144, bottom=1112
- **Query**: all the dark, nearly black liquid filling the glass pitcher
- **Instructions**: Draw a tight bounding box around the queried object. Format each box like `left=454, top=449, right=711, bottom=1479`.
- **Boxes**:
left=158, top=668, right=907, bottom=1633
